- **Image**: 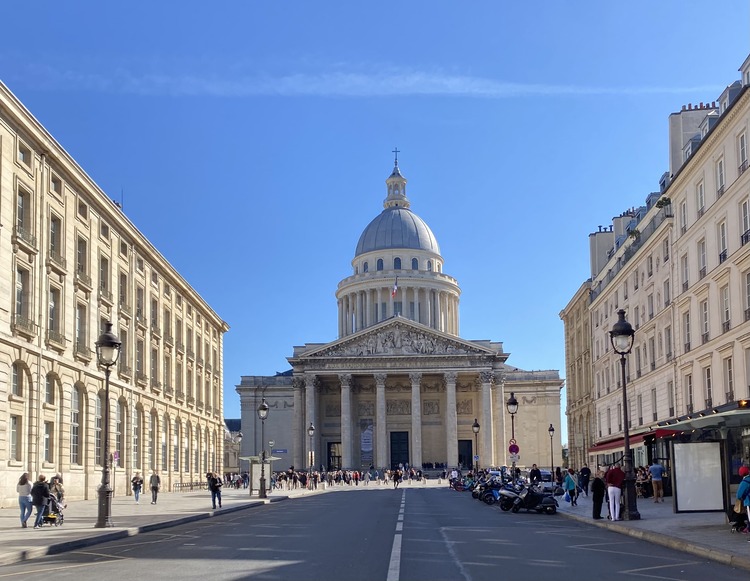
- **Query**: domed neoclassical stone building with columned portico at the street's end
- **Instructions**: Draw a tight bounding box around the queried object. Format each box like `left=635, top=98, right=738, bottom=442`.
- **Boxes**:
left=237, top=161, right=562, bottom=469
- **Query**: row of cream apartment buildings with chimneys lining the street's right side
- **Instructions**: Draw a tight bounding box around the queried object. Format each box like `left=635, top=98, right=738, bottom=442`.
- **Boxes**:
left=561, top=57, right=750, bottom=482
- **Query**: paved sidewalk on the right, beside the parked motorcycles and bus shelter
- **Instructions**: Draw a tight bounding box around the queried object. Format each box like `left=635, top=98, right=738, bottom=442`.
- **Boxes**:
left=558, top=495, right=750, bottom=571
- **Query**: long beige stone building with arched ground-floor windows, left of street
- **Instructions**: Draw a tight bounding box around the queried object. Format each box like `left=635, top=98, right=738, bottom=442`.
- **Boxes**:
left=0, top=84, right=228, bottom=506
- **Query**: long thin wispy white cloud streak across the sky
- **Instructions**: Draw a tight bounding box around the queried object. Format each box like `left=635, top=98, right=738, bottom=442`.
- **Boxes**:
left=4, top=66, right=722, bottom=99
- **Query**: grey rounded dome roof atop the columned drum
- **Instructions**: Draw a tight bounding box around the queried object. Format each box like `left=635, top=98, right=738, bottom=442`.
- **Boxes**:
left=355, top=206, right=440, bottom=256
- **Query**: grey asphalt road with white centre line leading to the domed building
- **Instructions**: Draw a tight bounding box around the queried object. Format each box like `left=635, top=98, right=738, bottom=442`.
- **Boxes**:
left=0, top=487, right=747, bottom=581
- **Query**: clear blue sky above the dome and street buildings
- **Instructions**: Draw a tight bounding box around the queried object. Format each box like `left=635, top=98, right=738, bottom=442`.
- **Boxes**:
left=0, top=0, right=750, bottom=441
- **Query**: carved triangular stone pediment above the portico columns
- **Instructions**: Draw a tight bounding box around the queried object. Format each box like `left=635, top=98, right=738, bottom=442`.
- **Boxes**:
left=299, top=317, right=498, bottom=359
